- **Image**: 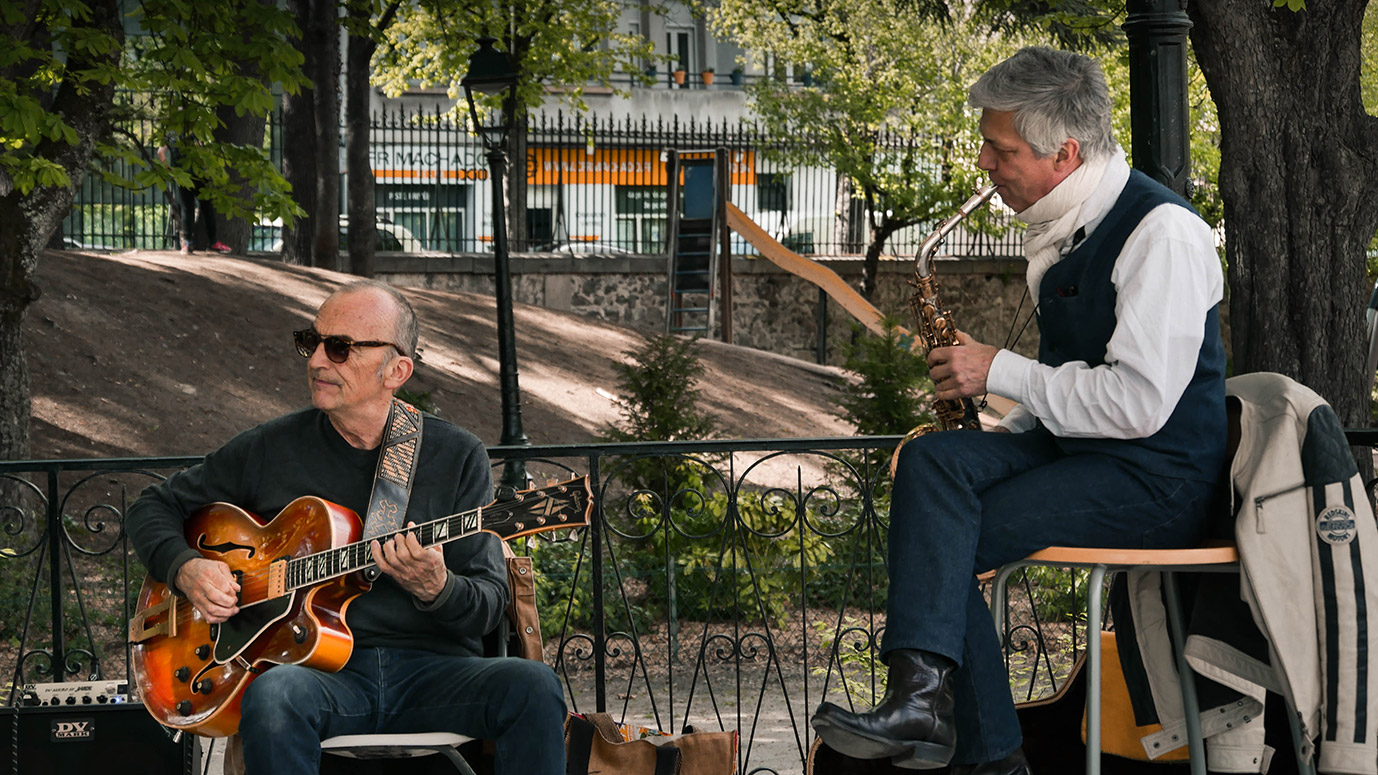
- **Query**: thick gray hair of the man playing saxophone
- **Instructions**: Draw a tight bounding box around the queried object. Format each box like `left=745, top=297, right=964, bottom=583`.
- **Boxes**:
left=967, top=46, right=1116, bottom=161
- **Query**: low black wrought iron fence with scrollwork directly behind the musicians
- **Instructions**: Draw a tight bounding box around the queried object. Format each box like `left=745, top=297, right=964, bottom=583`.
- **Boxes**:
left=0, top=437, right=1113, bottom=774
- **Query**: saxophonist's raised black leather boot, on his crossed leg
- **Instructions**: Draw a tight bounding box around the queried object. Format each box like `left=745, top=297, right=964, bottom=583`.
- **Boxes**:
left=812, top=650, right=956, bottom=769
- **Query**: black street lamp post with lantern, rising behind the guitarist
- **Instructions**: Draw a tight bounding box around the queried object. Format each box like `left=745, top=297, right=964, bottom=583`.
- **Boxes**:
left=460, top=37, right=526, bottom=490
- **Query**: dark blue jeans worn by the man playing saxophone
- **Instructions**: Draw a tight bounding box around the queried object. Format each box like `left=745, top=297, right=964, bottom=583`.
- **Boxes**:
left=881, top=429, right=1217, bottom=764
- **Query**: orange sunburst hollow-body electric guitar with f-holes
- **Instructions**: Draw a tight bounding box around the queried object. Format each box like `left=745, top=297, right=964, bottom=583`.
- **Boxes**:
left=130, top=477, right=593, bottom=736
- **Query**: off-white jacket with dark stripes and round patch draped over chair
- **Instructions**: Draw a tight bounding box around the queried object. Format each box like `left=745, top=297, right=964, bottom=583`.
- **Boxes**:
left=1130, top=374, right=1378, bottom=775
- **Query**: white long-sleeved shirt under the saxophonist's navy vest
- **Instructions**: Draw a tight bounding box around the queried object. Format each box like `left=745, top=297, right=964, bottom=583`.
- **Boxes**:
left=987, top=161, right=1225, bottom=439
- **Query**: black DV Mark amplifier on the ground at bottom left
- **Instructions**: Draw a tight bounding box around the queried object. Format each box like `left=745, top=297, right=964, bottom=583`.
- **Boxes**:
left=0, top=701, right=201, bottom=775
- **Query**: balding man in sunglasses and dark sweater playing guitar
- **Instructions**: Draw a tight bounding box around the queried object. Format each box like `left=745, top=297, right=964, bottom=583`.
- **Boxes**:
left=127, top=280, right=565, bottom=775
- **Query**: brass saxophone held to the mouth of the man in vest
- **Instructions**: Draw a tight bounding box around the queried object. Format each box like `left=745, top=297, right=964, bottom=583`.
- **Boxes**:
left=890, top=183, right=995, bottom=477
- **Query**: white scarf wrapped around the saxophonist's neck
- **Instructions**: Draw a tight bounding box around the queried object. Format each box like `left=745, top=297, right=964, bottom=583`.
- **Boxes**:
left=1016, top=146, right=1129, bottom=303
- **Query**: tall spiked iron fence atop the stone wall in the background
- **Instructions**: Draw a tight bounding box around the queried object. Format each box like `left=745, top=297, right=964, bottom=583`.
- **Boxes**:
left=63, top=102, right=1020, bottom=256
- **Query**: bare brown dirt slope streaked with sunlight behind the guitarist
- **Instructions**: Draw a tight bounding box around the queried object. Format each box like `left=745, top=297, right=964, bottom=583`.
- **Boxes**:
left=26, top=245, right=852, bottom=459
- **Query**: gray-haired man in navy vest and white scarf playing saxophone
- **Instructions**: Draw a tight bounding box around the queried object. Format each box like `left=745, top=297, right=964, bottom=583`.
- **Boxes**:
left=813, top=48, right=1226, bottom=775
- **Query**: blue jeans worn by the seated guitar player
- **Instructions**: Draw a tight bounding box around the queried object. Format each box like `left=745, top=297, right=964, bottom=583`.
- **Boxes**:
left=240, top=648, right=565, bottom=775
